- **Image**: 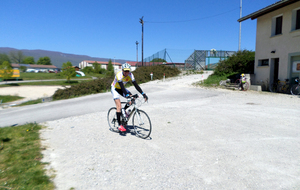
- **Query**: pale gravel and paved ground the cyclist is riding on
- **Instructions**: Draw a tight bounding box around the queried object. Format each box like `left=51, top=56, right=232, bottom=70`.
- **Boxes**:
left=37, top=76, right=300, bottom=190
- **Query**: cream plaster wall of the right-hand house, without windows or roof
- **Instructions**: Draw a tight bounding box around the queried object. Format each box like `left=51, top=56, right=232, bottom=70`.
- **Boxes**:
left=252, top=2, right=300, bottom=84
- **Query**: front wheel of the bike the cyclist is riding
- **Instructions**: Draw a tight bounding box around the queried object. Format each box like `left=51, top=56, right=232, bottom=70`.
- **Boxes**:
left=132, top=110, right=152, bottom=139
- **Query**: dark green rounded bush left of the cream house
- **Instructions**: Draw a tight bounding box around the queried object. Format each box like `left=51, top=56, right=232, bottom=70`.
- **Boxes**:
left=214, top=50, right=255, bottom=76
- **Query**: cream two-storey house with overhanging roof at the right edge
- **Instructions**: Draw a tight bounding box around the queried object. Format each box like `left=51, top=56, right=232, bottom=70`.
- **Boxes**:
left=238, top=0, right=300, bottom=84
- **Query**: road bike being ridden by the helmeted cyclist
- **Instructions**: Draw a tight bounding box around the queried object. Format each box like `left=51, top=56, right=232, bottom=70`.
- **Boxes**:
left=107, top=94, right=152, bottom=139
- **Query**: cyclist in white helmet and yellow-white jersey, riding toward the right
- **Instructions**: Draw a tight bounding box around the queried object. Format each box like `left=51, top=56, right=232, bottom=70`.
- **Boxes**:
left=111, top=63, right=148, bottom=132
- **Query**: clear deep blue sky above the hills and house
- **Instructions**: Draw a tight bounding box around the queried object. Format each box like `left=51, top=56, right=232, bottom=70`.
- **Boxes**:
left=0, top=0, right=278, bottom=62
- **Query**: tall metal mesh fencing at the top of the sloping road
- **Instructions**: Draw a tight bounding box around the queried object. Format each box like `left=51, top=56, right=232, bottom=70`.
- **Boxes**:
left=138, top=49, right=235, bottom=70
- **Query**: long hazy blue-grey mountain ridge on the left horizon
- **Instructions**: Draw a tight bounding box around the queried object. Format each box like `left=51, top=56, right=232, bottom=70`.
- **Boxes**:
left=0, top=47, right=130, bottom=68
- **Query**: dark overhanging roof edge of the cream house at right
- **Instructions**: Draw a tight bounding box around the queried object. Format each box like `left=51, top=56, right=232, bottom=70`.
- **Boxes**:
left=238, top=0, right=300, bottom=22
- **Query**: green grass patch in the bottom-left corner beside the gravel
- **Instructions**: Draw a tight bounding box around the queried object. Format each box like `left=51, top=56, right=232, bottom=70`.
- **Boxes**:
left=0, top=123, right=54, bottom=190
